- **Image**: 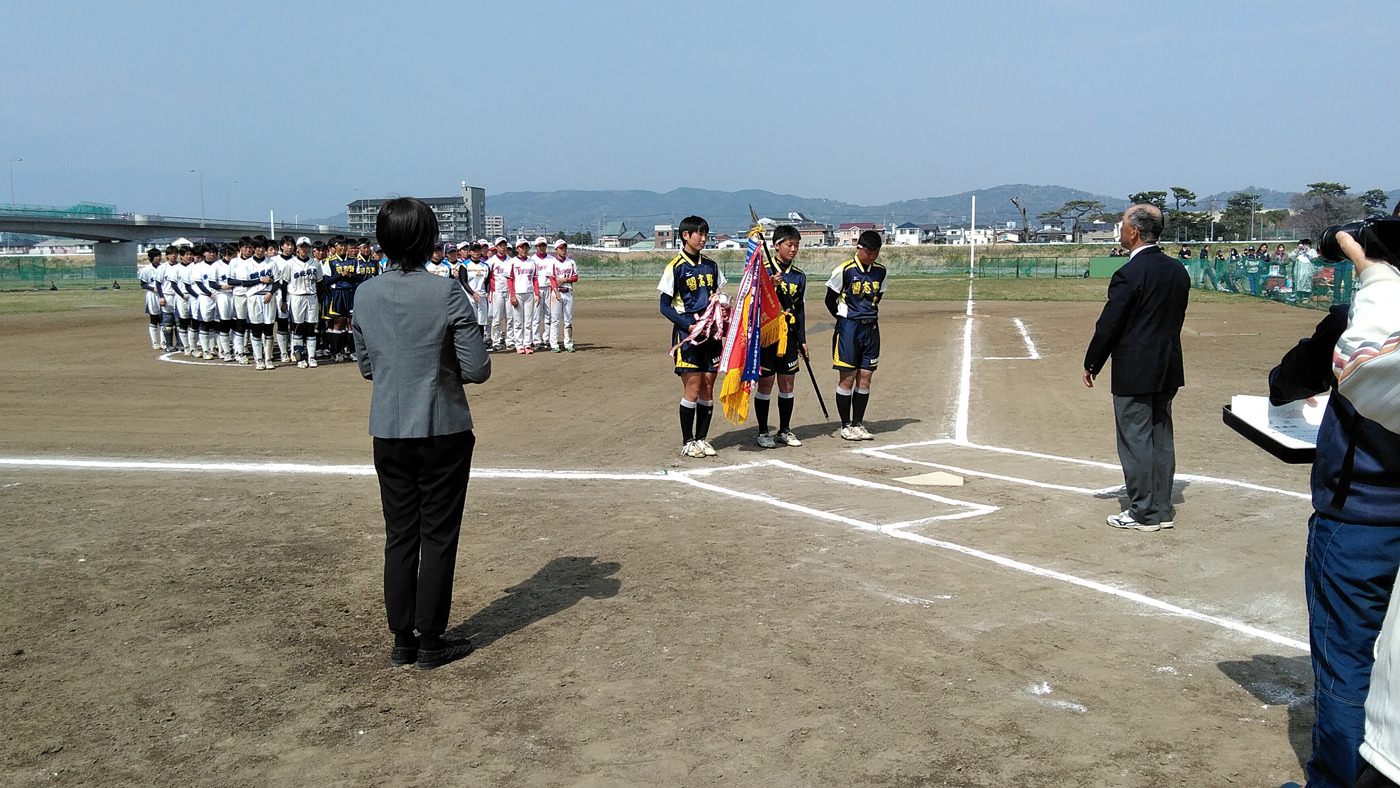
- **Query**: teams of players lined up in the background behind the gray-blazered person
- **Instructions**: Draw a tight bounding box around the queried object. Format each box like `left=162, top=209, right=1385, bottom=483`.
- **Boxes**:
left=137, top=235, right=578, bottom=370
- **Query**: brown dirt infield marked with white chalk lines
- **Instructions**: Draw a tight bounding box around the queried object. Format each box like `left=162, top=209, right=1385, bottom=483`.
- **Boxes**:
left=0, top=289, right=1320, bottom=787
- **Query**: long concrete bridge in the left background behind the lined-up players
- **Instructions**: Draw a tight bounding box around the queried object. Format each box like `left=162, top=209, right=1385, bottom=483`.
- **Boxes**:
left=0, top=206, right=350, bottom=266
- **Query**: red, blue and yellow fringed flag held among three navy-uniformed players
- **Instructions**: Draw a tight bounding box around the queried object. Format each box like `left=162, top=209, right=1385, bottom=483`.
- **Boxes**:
left=720, top=225, right=787, bottom=424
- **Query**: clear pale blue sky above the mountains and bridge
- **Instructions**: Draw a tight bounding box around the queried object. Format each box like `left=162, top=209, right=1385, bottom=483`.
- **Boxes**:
left=0, top=0, right=1400, bottom=218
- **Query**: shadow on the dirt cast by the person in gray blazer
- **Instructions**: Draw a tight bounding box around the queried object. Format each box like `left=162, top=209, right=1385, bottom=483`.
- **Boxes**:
left=448, top=556, right=622, bottom=648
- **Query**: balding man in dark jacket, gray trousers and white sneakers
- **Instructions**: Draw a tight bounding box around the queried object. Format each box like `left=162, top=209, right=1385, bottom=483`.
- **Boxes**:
left=1084, top=206, right=1191, bottom=530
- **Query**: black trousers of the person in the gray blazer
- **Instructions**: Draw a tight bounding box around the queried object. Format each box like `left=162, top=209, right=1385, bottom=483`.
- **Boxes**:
left=374, top=430, right=476, bottom=635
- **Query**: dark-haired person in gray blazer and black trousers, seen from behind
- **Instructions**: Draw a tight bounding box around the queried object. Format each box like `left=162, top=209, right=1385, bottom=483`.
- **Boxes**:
left=351, top=197, right=491, bottom=670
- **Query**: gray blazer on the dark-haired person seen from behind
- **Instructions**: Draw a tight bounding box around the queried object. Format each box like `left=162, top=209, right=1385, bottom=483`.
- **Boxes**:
left=351, top=269, right=491, bottom=438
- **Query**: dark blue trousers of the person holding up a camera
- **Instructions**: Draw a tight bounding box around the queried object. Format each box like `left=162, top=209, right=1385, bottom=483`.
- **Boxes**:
left=1303, top=514, right=1400, bottom=788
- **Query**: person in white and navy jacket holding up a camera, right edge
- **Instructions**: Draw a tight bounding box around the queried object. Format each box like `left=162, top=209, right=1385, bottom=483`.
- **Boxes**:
left=1268, top=225, right=1400, bottom=788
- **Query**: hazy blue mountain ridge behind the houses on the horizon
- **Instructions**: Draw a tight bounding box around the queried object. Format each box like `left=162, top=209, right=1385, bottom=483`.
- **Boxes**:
left=486, top=183, right=1126, bottom=234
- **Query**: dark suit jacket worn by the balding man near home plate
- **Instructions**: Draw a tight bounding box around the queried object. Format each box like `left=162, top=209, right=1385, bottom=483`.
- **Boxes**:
left=1084, top=245, right=1191, bottom=396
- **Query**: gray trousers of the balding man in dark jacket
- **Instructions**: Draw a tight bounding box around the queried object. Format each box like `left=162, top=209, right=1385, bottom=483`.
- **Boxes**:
left=1113, top=389, right=1176, bottom=523
